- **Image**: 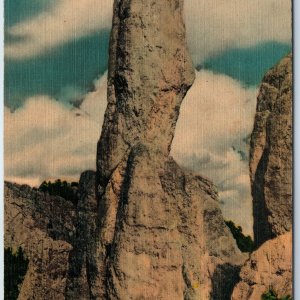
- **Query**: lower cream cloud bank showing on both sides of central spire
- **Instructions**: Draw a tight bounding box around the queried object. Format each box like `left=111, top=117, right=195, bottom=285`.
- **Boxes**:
left=4, top=71, right=257, bottom=233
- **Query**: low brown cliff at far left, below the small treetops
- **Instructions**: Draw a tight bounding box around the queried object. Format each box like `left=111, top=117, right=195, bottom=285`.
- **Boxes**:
left=4, top=183, right=75, bottom=299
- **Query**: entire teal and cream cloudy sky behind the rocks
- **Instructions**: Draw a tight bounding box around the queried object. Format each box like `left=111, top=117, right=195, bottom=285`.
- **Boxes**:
left=4, top=0, right=291, bottom=233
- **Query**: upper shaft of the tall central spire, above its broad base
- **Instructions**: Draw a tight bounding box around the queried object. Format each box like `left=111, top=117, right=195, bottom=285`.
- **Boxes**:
left=97, top=0, right=195, bottom=190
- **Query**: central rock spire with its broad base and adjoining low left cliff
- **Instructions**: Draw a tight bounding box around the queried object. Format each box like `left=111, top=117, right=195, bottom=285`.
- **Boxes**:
left=5, top=0, right=245, bottom=300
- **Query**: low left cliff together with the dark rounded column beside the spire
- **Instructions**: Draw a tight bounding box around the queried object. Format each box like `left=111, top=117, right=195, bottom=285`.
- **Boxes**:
left=4, top=171, right=97, bottom=299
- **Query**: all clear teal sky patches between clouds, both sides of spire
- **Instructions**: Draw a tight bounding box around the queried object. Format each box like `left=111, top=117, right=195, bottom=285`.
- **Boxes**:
left=4, top=0, right=291, bottom=109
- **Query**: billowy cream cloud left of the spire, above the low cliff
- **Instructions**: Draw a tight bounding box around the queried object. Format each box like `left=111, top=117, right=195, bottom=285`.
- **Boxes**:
left=4, top=74, right=106, bottom=186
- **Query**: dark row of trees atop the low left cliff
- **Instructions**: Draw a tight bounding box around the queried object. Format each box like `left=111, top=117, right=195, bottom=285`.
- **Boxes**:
left=39, top=179, right=78, bottom=205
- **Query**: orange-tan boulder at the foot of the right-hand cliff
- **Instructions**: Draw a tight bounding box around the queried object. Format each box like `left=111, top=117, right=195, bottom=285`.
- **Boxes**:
left=232, top=232, right=293, bottom=300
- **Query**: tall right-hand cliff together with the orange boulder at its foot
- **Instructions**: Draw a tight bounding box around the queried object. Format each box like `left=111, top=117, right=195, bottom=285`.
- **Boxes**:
left=232, top=54, right=293, bottom=300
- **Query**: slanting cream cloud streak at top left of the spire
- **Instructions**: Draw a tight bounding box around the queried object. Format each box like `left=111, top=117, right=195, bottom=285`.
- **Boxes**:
left=5, top=0, right=113, bottom=59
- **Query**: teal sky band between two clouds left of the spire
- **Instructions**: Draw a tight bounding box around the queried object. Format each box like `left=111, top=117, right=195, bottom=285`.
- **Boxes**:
left=5, top=31, right=109, bottom=108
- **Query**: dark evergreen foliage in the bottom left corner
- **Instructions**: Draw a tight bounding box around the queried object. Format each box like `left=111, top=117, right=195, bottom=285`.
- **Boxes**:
left=4, top=247, right=29, bottom=300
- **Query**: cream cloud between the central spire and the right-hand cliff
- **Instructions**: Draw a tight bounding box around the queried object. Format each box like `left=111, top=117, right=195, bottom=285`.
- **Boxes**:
left=171, top=71, right=257, bottom=233
